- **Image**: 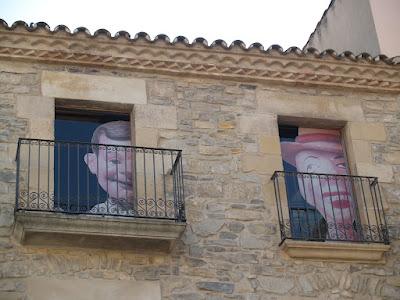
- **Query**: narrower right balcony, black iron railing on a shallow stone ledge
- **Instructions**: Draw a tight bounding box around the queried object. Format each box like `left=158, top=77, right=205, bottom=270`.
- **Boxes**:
left=271, top=171, right=390, bottom=263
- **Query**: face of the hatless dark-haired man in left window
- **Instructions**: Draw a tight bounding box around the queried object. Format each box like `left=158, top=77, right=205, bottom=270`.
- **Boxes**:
left=85, top=133, right=134, bottom=206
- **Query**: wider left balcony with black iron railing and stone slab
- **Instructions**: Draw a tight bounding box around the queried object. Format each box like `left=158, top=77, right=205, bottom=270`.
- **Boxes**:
left=14, top=139, right=185, bottom=252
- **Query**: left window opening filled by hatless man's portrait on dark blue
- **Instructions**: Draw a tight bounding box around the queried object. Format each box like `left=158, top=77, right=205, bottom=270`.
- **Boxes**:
left=54, top=110, right=133, bottom=214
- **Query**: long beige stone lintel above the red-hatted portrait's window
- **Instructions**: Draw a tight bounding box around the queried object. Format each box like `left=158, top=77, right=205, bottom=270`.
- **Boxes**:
left=257, top=90, right=364, bottom=121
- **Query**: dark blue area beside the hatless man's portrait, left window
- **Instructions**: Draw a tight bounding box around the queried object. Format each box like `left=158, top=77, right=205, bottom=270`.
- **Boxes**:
left=54, top=109, right=129, bottom=212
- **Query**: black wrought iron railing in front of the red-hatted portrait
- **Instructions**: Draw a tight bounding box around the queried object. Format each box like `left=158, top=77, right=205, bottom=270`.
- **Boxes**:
left=271, top=171, right=389, bottom=244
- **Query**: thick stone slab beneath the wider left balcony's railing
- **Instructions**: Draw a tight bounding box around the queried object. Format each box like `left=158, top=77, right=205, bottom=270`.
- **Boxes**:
left=13, top=211, right=186, bottom=253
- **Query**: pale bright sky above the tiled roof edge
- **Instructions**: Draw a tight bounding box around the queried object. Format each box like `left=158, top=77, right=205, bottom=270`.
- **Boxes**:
left=0, top=0, right=330, bottom=49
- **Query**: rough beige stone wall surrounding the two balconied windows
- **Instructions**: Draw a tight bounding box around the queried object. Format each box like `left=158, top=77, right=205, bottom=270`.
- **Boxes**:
left=0, top=60, right=400, bottom=300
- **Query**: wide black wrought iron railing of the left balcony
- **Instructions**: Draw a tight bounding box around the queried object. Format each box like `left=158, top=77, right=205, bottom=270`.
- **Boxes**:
left=16, top=139, right=185, bottom=222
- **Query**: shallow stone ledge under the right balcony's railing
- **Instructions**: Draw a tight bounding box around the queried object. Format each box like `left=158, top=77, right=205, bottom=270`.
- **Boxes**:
left=280, top=240, right=390, bottom=264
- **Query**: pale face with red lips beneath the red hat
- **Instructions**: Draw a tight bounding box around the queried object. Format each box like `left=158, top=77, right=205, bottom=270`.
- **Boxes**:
left=296, top=150, right=355, bottom=224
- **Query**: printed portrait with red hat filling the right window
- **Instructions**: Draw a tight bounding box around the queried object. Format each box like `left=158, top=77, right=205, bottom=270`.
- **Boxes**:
left=281, top=128, right=358, bottom=240
